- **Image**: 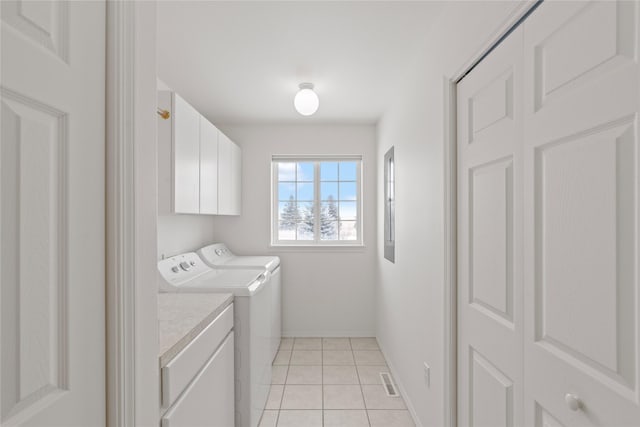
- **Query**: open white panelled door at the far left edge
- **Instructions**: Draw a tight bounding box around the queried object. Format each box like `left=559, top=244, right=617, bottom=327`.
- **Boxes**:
left=0, top=1, right=105, bottom=426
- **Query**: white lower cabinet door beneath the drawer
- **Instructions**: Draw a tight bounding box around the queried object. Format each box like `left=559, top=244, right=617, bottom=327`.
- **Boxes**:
left=162, top=331, right=235, bottom=427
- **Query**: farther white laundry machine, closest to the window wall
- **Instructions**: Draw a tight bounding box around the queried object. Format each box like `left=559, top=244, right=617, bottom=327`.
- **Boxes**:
left=198, top=243, right=282, bottom=361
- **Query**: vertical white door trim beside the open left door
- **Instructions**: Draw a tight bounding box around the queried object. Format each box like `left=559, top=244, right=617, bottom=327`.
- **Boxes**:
left=106, top=1, right=135, bottom=426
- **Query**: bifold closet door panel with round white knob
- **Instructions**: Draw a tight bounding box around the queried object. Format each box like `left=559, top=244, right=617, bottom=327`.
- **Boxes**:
left=524, top=1, right=640, bottom=426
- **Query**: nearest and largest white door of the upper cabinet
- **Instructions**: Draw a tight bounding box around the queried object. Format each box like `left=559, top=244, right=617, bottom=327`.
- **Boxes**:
left=172, top=94, right=200, bottom=214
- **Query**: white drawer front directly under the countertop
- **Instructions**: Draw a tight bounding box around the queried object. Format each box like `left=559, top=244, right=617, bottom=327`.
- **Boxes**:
left=161, top=304, right=233, bottom=407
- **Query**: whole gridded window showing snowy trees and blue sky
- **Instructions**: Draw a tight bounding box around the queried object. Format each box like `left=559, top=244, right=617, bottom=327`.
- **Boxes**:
left=272, top=156, right=362, bottom=246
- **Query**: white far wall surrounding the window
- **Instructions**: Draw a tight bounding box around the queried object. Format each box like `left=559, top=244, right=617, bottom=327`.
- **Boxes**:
left=213, top=125, right=377, bottom=336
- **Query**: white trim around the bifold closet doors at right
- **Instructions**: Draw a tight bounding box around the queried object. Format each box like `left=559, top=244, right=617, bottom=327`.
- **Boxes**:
left=442, top=0, right=542, bottom=426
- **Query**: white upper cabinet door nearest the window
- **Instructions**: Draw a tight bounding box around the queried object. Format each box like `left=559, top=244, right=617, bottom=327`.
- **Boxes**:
left=218, top=132, right=242, bottom=215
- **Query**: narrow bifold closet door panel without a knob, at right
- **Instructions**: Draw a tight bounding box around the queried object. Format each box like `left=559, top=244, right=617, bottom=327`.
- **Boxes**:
left=457, top=25, right=523, bottom=427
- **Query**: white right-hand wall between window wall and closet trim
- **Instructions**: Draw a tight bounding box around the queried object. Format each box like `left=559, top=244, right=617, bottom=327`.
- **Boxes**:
left=376, top=2, right=518, bottom=426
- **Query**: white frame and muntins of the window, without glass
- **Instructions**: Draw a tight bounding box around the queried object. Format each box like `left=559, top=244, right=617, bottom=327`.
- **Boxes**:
left=271, top=154, right=364, bottom=248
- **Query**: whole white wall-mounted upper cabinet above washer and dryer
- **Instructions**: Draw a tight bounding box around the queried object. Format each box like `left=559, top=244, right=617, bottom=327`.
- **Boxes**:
left=158, top=91, right=242, bottom=215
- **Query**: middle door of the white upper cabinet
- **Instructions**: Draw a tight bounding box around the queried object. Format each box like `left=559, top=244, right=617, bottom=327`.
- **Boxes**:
left=200, top=116, right=218, bottom=214
